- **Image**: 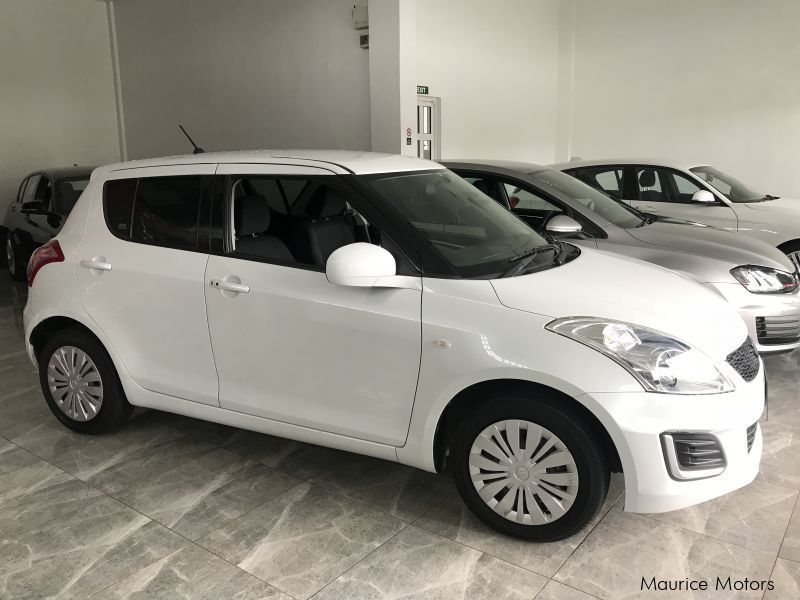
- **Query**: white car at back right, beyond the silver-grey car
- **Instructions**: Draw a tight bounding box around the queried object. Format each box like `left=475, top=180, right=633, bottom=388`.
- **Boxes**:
left=551, top=159, right=800, bottom=270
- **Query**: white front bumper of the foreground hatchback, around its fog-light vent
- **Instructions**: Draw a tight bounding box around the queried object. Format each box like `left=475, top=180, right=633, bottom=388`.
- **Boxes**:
left=590, top=365, right=765, bottom=513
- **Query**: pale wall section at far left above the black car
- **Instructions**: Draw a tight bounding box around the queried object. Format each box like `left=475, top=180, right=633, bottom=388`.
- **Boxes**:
left=0, top=0, right=119, bottom=212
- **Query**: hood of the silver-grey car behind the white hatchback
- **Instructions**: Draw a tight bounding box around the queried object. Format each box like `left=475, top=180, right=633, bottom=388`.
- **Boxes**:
left=625, top=219, right=794, bottom=272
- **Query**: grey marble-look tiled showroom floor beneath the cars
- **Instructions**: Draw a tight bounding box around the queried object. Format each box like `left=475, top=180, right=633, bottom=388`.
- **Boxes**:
left=0, top=271, right=800, bottom=600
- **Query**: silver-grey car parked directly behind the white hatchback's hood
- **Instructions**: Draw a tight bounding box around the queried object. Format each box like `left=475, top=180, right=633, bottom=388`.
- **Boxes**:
left=443, top=160, right=800, bottom=353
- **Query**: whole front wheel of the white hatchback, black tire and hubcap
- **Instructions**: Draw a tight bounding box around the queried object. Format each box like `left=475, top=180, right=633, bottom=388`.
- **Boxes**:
left=451, top=392, right=611, bottom=542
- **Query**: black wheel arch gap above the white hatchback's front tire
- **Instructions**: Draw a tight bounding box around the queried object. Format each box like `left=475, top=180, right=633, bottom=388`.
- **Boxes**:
left=433, top=379, right=622, bottom=472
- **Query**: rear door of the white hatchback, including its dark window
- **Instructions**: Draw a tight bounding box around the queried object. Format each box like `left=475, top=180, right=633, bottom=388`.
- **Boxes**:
left=75, top=164, right=219, bottom=406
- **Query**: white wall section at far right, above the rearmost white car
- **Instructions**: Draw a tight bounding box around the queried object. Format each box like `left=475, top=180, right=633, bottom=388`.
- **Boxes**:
left=558, top=0, right=800, bottom=197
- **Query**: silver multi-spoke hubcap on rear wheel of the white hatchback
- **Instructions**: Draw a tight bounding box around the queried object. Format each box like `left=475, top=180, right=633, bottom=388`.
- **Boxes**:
left=47, top=346, right=103, bottom=421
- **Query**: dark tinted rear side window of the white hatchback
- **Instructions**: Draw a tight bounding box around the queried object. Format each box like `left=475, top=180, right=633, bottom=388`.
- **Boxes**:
left=104, top=175, right=203, bottom=250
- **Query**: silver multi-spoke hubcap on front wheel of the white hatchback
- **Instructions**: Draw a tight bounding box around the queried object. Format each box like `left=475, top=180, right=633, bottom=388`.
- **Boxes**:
left=469, top=420, right=578, bottom=525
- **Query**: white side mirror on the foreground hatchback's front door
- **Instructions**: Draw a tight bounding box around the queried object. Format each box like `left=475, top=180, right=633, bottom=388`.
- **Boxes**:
left=325, top=242, right=399, bottom=287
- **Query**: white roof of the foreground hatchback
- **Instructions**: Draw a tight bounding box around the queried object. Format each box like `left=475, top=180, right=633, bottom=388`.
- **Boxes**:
left=94, top=150, right=442, bottom=177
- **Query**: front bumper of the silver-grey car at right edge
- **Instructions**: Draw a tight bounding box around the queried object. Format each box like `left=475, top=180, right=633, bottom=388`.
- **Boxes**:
left=704, top=283, right=800, bottom=354
